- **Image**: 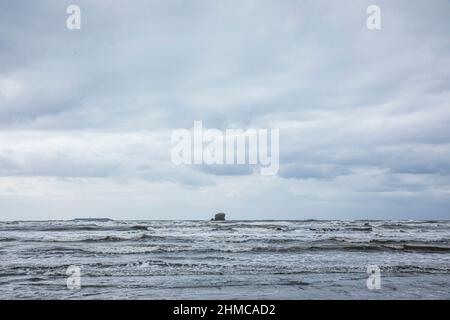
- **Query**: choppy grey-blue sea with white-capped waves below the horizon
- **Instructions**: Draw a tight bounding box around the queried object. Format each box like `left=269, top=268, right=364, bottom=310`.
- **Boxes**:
left=0, top=220, right=450, bottom=299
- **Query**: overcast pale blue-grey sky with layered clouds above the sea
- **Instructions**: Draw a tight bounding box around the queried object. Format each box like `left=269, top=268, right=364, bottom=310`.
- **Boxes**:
left=0, top=0, right=450, bottom=220
